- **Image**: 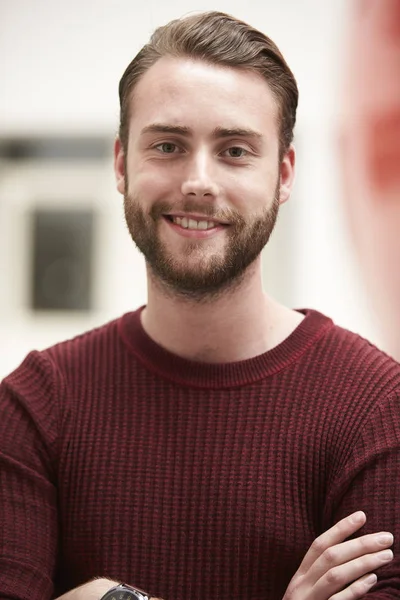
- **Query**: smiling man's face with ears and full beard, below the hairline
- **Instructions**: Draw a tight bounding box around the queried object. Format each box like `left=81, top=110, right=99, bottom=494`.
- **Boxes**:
left=115, top=58, right=294, bottom=299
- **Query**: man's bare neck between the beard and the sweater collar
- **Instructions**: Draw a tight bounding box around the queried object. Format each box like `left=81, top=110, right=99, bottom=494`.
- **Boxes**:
left=142, top=260, right=302, bottom=363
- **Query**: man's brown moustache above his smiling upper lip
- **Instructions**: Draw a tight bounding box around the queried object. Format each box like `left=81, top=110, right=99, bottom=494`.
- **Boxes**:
left=149, top=198, right=244, bottom=224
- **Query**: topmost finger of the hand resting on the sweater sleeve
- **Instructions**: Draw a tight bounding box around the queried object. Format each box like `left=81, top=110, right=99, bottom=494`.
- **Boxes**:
left=297, top=511, right=367, bottom=574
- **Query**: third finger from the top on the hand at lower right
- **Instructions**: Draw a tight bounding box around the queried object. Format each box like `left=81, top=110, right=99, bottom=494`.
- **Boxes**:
left=313, top=550, right=393, bottom=600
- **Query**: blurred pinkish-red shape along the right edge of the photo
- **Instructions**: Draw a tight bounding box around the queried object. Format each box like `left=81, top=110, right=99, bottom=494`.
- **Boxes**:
left=340, top=0, right=400, bottom=360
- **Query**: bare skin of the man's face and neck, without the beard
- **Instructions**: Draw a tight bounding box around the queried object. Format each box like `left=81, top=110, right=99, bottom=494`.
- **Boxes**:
left=115, top=58, right=302, bottom=362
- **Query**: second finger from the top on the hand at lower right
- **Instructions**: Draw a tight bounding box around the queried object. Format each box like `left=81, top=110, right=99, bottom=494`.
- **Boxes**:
left=309, top=531, right=393, bottom=582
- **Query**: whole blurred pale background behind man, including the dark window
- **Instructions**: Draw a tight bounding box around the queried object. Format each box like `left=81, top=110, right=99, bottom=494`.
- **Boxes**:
left=0, top=0, right=382, bottom=378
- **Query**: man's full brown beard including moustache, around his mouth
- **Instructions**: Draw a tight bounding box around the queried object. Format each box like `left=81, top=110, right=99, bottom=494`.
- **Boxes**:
left=124, top=182, right=279, bottom=301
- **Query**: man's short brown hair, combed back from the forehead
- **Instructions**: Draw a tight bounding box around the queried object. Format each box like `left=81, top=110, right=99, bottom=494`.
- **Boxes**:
left=119, top=11, right=298, bottom=156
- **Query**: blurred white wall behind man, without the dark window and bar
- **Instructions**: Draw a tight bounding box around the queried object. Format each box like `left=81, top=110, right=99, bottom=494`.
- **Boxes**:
left=0, top=0, right=380, bottom=377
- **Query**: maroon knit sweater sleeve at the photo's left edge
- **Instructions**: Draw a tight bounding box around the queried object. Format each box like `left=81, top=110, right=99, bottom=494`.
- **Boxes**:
left=0, top=352, right=58, bottom=600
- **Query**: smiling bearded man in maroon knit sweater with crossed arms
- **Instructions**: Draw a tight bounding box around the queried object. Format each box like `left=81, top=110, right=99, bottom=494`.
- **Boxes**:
left=0, top=13, right=400, bottom=600
